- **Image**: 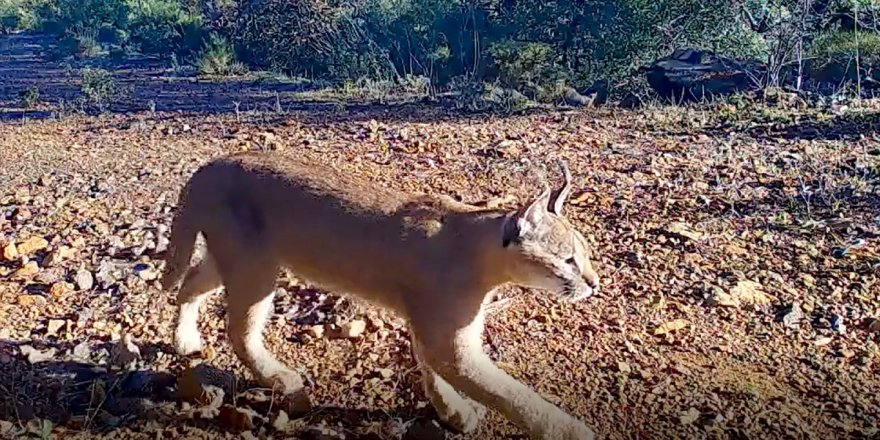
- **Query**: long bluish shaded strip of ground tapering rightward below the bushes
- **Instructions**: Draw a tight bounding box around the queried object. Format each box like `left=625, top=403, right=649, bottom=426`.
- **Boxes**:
left=0, top=33, right=564, bottom=122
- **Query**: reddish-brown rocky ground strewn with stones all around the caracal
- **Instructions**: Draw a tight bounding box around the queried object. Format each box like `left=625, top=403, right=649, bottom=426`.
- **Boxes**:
left=0, top=31, right=880, bottom=439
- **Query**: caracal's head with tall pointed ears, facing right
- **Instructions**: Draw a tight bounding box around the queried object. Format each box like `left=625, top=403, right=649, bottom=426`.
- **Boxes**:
left=502, top=162, right=599, bottom=301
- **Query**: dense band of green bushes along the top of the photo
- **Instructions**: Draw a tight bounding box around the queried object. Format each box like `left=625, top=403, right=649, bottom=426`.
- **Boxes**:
left=8, top=0, right=880, bottom=97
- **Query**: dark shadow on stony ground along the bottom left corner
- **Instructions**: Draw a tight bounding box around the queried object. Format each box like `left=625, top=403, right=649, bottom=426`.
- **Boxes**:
left=0, top=340, right=443, bottom=439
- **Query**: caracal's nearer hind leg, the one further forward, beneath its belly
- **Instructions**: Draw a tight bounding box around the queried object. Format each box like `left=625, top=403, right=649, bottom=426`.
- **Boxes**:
left=220, top=253, right=303, bottom=394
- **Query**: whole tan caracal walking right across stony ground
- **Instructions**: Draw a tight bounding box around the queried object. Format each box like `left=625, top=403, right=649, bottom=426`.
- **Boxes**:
left=161, top=152, right=599, bottom=440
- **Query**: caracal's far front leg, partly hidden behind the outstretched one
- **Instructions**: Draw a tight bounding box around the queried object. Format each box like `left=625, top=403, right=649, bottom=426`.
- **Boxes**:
left=411, top=337, right=486, bottom=433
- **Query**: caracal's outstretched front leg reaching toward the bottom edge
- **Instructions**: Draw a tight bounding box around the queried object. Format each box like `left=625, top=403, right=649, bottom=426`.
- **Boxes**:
left=416, top=313, right=595, bottom=440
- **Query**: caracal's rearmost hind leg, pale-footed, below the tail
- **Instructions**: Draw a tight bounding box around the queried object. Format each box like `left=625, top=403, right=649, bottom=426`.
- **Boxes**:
left=174, top=253, right=223, bottom=355
